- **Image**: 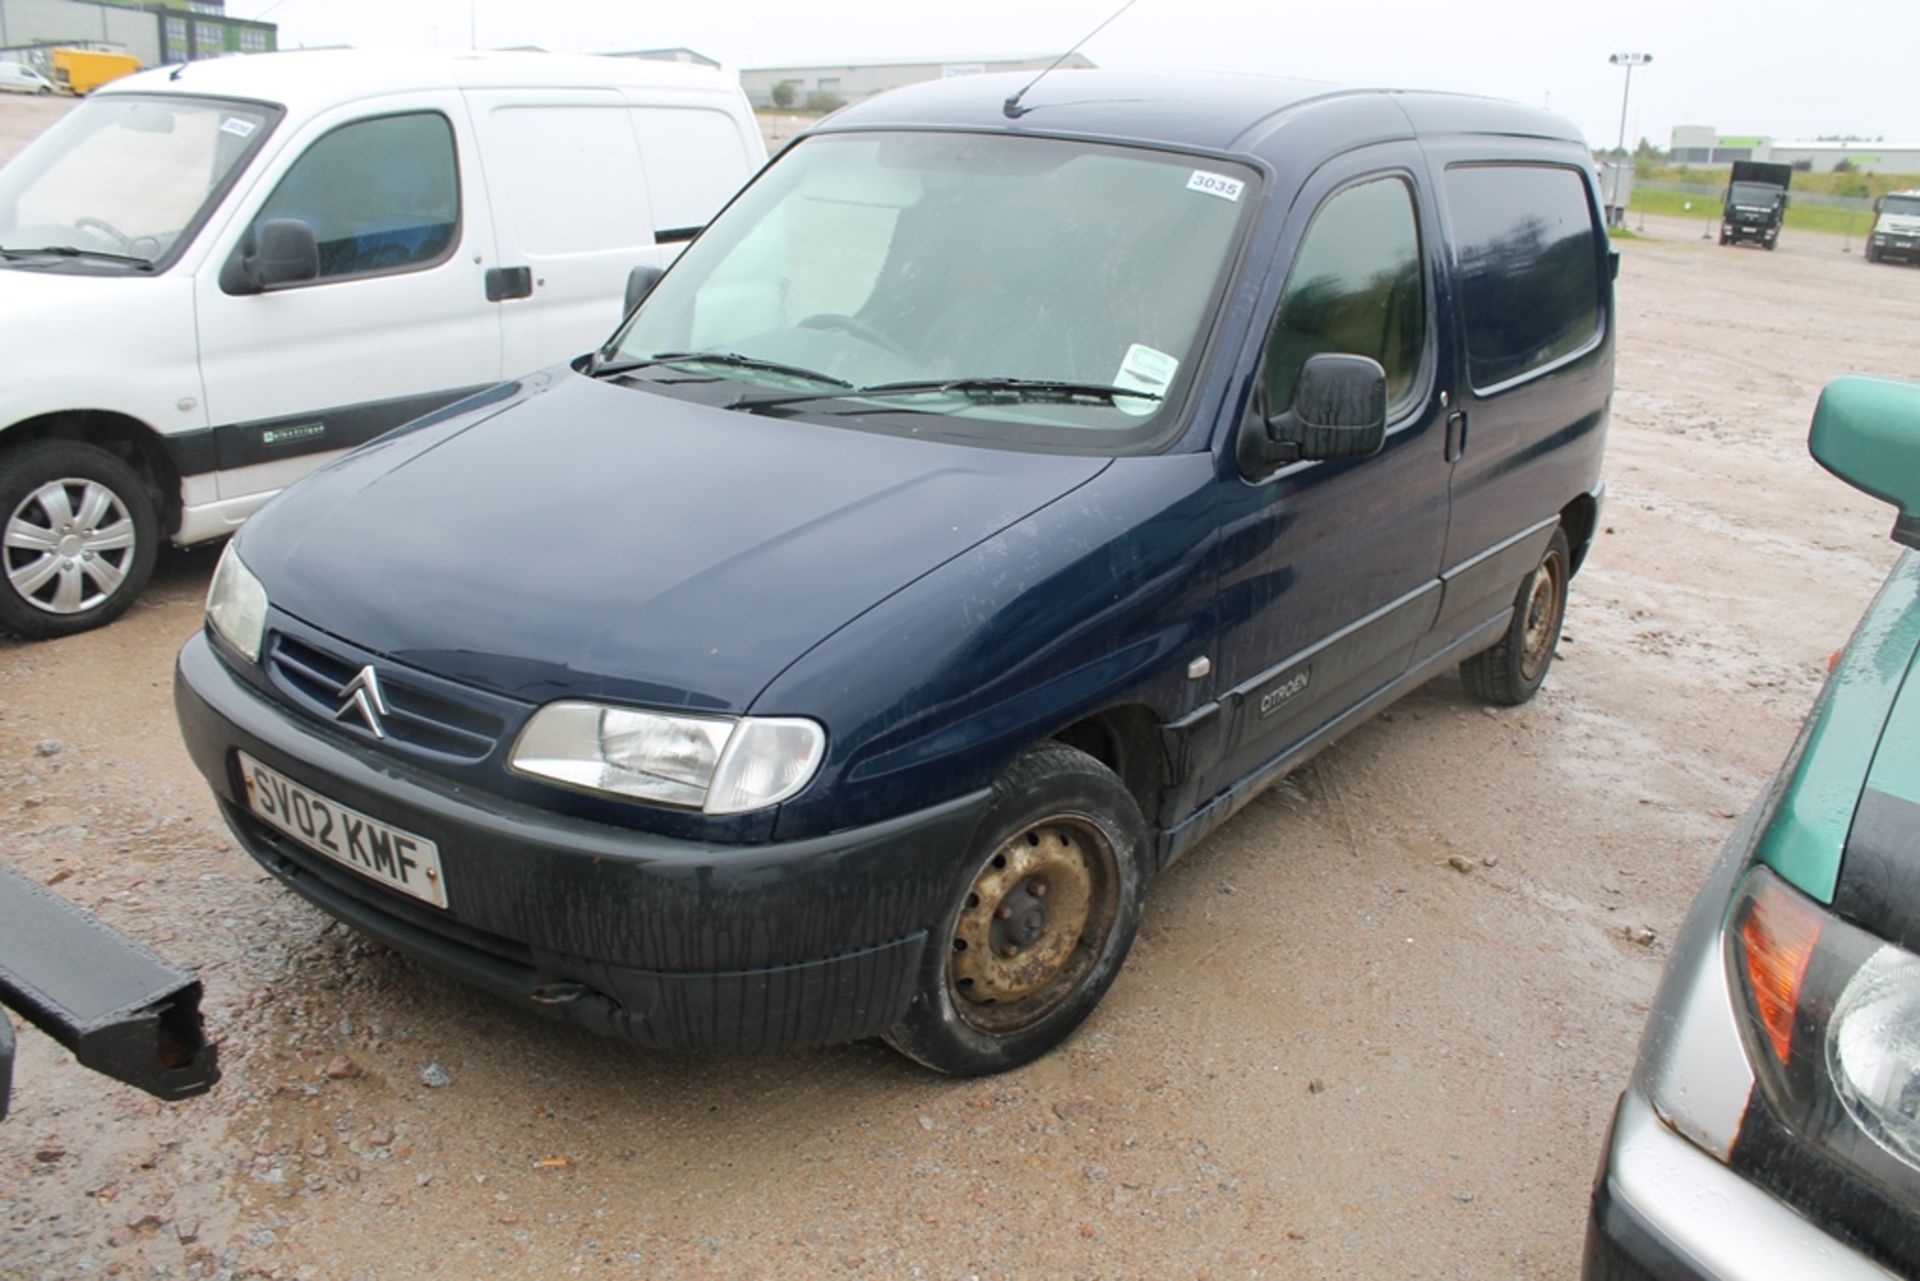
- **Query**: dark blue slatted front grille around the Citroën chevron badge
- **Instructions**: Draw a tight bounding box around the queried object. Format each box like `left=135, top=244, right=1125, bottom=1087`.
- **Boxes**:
left=265, top=632, right=507, bottom=761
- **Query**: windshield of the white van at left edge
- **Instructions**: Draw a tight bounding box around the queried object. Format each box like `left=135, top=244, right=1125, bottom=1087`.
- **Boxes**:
left=0, top=94, right=275, bottom=265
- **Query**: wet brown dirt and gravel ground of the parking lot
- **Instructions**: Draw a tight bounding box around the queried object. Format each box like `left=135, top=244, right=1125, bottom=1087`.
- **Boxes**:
left=0, top=95, right=1920, bottom=1279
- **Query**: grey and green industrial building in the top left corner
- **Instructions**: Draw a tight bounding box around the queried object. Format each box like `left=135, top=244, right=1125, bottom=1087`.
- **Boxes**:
left=0, top=0, right=278, bottom=73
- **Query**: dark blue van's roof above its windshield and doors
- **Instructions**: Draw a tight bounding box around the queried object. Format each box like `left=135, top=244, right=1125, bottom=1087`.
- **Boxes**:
left=822, top=69, right=1586, bottom=152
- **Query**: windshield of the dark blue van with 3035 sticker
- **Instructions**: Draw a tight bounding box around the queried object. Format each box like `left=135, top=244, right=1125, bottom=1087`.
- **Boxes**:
left=607, top=133, right=1256, bottom=447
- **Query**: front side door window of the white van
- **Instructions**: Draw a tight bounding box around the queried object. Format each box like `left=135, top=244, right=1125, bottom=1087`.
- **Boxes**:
left=253, top=111, right=461, bottom=280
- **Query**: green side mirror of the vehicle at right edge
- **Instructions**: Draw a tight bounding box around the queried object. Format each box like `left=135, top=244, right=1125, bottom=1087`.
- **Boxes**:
left=1807, top=375, right=1920, bottom=547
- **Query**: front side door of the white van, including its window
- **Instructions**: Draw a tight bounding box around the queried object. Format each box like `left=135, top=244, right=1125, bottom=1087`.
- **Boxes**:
left=194, top=94, right=501, bottom=499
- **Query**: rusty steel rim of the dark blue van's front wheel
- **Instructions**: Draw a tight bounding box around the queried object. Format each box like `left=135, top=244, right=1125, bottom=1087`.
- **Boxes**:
left=947, top=814, right=1117, bottom=1033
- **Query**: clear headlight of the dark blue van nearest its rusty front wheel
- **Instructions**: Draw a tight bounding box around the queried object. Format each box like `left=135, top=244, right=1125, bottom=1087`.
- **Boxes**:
left=513, top=703, right=828, bottom=814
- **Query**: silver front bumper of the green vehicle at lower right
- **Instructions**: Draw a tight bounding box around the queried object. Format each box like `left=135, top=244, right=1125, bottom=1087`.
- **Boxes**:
left=1582, top=1091, right=1893, bottom=1281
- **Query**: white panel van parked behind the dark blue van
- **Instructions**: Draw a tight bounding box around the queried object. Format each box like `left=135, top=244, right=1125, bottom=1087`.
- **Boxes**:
left=0, top=50, right=766, bottom=638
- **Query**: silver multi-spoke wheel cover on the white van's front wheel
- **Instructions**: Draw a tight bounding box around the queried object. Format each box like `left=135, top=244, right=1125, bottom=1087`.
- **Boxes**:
left=0, top=476, right=138, bottom=615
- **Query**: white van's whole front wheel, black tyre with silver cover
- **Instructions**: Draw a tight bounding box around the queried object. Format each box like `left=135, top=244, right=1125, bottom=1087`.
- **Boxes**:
left=0, top=440, right=159, bottom=640
